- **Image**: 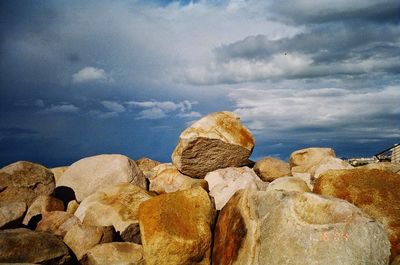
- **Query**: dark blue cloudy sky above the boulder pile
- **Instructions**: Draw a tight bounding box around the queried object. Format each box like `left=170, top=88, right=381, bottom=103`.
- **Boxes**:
left=0, top=0, right=400, bottom=167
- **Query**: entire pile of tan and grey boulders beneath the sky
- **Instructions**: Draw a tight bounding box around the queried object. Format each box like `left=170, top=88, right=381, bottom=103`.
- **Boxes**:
left=0, top=112, right=400, bottom=265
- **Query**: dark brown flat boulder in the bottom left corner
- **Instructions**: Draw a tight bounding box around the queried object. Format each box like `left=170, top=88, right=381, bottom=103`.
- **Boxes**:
left=0, top=228, right=71, bottom=265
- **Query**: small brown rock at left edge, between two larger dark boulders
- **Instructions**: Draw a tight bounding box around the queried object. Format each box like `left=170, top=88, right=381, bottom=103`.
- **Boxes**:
left=0, top=202, right=26, bottom=229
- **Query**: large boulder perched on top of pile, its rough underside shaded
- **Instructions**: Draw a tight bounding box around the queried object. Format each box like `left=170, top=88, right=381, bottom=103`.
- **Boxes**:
left=171, top=111, right=255, bottom=178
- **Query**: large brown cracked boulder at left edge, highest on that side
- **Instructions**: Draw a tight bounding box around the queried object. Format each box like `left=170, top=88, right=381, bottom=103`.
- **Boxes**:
left=0, top=161, right=55, bottom=207
